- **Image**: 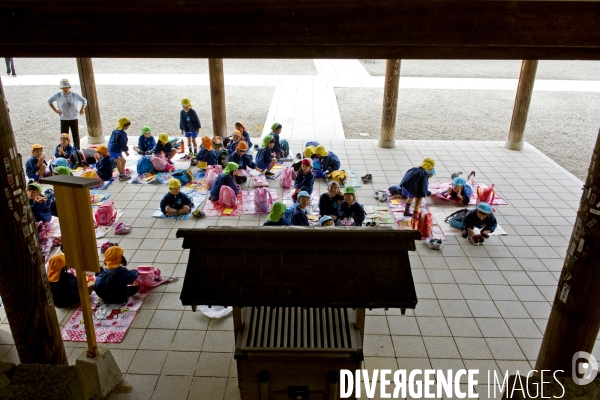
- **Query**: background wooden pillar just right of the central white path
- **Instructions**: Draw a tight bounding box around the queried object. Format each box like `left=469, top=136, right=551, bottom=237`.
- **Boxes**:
left=379, top=60, right=400, bottom=149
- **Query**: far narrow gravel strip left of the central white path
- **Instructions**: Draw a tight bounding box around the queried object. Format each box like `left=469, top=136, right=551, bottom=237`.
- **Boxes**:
left=10, top=58, right=317, bottom=76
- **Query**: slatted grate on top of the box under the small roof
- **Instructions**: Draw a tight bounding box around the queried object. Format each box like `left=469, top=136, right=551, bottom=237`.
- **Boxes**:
left=243, top=307, right=356, bottom=350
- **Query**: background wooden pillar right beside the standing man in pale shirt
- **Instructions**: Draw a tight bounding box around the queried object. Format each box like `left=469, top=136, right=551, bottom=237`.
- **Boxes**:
left=77, top=58, right=105, bottom=144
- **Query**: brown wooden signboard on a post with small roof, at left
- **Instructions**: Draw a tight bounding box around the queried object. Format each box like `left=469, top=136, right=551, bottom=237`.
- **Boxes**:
left=41, top=175, right=100, bottom=358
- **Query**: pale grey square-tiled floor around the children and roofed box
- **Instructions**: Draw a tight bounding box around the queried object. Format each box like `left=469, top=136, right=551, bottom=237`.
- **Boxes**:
left=0, top=140, right=600, bottom=400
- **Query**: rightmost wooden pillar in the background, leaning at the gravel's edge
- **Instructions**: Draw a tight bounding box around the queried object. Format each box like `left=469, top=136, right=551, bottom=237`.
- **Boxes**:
left=504, top=60, right=538, bottom=150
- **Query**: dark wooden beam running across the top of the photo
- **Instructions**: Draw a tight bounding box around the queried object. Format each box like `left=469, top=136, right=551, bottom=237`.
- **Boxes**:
left=0, top=0, right=600, bottom=60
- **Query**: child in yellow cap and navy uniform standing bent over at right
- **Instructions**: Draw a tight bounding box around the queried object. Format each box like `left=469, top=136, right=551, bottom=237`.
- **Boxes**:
left=388, top=158, right=435, bottom=217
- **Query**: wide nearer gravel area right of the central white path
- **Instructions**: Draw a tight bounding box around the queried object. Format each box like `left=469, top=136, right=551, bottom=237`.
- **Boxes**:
left=335, top=88, right=600, bottom=180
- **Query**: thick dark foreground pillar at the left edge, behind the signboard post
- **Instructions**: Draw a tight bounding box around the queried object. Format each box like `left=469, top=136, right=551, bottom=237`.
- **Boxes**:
left=0, top=75, right=68, bottom=364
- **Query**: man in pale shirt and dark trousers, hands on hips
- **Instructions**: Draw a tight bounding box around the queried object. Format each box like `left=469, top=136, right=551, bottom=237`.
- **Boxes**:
left=48, top=79, right=87, bottom=149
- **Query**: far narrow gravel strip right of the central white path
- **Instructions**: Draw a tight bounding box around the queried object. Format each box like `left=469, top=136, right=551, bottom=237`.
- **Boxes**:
left=358, top=60, right=600, bottom=80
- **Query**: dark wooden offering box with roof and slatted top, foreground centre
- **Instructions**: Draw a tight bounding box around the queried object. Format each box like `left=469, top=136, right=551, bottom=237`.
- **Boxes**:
left=177, top=227, right=421, bottom=400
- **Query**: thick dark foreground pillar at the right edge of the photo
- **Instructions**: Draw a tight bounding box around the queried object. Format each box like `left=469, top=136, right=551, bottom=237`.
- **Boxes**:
left=536, top=127, right=600, bottom=376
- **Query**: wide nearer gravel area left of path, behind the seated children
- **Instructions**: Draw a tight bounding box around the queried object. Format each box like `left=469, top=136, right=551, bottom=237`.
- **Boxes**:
left=4, top=85, right=275, bottom=161
